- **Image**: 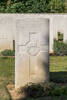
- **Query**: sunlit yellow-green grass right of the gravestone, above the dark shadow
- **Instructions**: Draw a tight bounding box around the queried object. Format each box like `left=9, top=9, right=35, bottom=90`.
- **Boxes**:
left=50, top=56, right=67, bottom=72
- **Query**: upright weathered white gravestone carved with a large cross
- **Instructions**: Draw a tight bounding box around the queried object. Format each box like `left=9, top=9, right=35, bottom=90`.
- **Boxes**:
left=15, top=17, right=49, bottom=88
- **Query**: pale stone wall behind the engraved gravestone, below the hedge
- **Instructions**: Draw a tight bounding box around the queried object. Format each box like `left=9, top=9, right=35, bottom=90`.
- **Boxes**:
left=0, top=14, right=67, bottom=53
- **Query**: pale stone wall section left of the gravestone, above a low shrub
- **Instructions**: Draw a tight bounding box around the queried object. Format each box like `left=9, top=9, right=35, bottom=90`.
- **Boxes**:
left=0, top=15, right=14, bottom=51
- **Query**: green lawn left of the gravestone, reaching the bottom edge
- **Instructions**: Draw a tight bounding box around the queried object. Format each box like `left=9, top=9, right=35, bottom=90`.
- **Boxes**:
left=0, top=57, right=14, bottom=100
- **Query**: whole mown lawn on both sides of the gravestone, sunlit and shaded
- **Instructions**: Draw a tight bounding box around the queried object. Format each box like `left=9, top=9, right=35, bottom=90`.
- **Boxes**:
left=0, top=56, right=67, bottom=100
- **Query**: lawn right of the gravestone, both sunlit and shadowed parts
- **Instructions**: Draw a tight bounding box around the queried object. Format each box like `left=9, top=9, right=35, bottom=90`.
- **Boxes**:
left=50, top=56, right=67, bottom=83
